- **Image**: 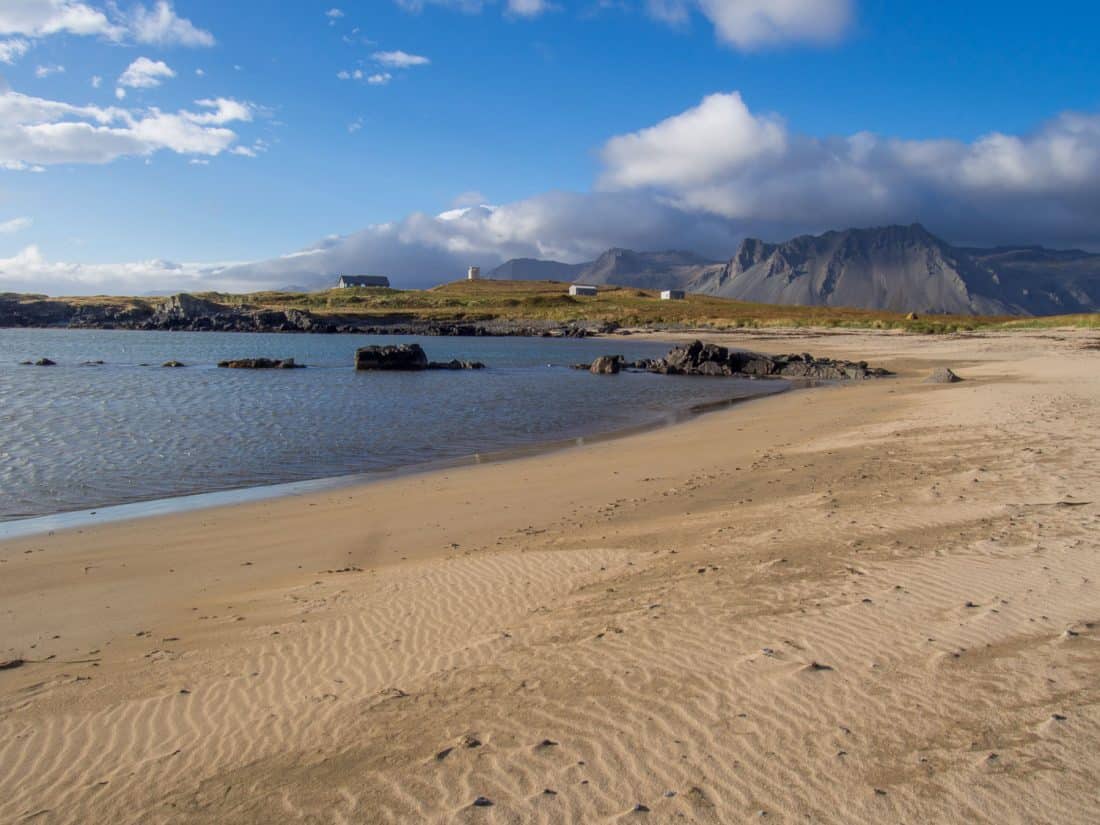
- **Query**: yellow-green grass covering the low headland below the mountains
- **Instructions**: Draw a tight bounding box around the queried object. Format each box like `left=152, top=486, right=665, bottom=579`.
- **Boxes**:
left=21, top=281, right=1100, bottom=333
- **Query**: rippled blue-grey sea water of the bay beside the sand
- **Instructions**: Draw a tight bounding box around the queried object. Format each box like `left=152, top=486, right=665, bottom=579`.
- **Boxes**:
left=0, top=329, right=782, bottom=521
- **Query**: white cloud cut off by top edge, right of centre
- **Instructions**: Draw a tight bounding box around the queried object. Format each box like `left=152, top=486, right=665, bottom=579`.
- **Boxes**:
left=647, top=0, right=853, bottom=51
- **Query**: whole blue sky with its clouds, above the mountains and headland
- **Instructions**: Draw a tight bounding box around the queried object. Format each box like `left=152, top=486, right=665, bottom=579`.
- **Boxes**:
left=0, top=0, right=1100, bottom=292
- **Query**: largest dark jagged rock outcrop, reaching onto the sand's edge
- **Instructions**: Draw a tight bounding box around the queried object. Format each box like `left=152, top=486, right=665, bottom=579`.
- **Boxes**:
left=574, top=341, right=890, bottom=381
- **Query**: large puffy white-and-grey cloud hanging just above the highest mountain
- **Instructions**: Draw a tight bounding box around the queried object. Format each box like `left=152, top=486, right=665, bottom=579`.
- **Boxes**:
left=600, top=92, right=1100, bottom=234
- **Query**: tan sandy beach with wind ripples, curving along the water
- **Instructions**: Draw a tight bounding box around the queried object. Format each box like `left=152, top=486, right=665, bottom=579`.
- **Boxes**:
left=0, top=330, right=1100, bottom=824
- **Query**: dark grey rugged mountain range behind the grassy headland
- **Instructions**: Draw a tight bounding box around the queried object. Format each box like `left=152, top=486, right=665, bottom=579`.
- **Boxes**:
left=491, top=223, right=1100, bottom=315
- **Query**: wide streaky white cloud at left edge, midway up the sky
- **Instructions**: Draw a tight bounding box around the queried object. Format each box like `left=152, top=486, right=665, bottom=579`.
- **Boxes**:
left=0, top=91, right=252, bottom=169
